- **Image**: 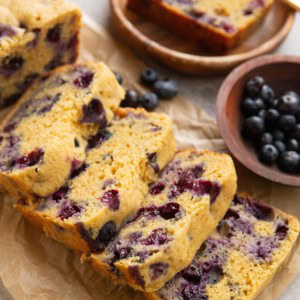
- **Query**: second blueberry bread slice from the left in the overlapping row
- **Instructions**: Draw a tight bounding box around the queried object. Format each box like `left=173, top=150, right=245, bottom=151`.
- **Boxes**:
left=17, top=109, right=175, bottom=254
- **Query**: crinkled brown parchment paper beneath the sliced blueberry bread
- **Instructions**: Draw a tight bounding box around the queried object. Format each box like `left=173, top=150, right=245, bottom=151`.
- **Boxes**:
left=0, top=15, right=300, bottom=300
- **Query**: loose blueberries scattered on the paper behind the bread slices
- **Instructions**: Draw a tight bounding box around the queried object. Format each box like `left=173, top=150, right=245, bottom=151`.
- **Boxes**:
left=115, top=68, right=178, bottom=111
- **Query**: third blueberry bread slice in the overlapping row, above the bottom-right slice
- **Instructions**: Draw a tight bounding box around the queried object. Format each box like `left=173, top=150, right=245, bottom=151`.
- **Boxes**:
left=91, top=150, right=236, bottom=292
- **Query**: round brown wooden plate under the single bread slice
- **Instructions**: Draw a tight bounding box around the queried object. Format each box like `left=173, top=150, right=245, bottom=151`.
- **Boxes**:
left=110, top=0, right=295, bottom=75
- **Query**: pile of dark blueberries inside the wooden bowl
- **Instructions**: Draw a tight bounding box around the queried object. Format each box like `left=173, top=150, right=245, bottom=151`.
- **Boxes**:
left=241, top=76, right=300, bottom=173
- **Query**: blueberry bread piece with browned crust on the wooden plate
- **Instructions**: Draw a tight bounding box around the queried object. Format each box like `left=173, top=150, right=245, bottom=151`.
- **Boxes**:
left=128, top=0, right=273, bottom=52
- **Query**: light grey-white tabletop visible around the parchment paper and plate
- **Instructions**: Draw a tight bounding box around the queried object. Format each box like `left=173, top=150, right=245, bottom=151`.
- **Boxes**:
left=0, top=0, right=300, bottom=300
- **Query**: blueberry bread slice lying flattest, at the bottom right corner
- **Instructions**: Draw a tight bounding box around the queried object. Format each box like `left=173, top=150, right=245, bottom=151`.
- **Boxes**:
left=145, top=196, right=299, bottom=300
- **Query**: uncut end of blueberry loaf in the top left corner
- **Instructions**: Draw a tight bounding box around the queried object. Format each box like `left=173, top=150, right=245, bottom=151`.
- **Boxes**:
left=0, top=0, right=81, bottom=107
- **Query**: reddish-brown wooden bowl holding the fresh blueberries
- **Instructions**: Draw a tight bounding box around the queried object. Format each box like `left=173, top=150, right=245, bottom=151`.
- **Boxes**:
left=217, top=55, right=300, bottom=186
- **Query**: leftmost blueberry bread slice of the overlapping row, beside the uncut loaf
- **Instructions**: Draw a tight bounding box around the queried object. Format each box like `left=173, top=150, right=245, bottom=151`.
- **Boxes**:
left=0, top=63, right=124, bottom=203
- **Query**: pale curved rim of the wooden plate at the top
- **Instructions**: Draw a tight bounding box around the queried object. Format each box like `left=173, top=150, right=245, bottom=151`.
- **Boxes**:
left=110, top=0, right=296, bottom=69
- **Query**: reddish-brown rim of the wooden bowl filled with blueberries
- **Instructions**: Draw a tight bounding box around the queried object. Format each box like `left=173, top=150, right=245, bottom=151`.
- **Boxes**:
left=216, top=55, right=300, bottom=187
